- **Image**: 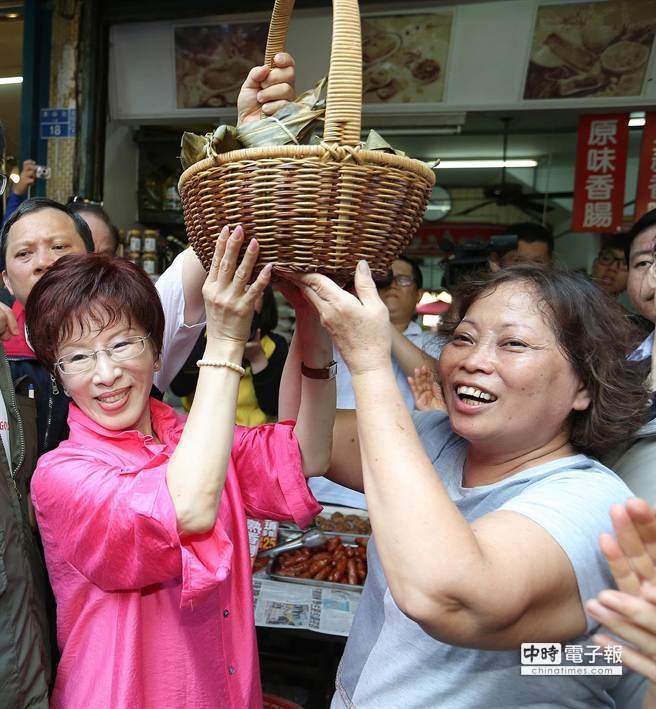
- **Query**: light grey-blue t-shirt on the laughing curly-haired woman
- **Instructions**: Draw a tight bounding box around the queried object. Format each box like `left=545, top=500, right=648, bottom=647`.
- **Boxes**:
left=332, top=412, right=631, bottom=709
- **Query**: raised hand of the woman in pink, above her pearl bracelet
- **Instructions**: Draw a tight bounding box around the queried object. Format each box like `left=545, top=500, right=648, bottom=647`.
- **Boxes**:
left=203, top=226, right=272, bottom=348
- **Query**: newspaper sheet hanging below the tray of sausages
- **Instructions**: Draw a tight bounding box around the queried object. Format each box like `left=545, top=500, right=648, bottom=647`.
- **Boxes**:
left=253, top=578, right=360, bottom=637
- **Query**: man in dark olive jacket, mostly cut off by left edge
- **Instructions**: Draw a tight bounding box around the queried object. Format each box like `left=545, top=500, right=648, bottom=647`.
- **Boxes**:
left=0, top=126, right=51, bottom=709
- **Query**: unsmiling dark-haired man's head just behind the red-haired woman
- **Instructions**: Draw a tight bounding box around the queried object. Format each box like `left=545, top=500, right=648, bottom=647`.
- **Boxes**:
left=2, top=208, right=87, bottom=305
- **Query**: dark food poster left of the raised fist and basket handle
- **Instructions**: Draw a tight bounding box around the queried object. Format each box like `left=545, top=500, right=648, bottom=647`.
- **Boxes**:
left=174, top=22, right=269, bottom=108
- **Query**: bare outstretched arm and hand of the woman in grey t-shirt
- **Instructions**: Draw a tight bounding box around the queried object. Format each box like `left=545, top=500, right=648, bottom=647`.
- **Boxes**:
left=296, top=262, right=585, bottom=649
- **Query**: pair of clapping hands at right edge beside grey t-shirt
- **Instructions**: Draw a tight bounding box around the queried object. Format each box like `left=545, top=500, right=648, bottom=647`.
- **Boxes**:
left=585, top=498, right=656, bottom=682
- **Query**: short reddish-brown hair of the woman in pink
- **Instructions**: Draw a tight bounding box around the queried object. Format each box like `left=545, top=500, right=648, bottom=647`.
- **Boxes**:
left=25, top=254, right=167, bottom=371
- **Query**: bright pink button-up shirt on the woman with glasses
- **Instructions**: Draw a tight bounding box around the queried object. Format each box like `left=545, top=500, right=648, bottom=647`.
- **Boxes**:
left=32, top=400, right=320, bottom=709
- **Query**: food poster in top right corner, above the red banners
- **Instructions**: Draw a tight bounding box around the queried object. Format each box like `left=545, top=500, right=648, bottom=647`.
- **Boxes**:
left=524, top=0, right=656, bottom=99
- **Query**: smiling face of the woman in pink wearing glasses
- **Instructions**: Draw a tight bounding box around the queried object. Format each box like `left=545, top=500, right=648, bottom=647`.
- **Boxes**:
left=57, top=319, right=156, bottom=435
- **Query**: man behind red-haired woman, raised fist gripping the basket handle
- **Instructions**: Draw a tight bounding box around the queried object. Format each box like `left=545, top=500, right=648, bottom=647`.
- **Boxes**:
left=0, top=54, right=294, bottom=455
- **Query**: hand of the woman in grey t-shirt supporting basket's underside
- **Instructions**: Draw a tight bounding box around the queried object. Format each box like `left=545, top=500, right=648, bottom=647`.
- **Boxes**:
left=290, top=261, right=392, bottom=376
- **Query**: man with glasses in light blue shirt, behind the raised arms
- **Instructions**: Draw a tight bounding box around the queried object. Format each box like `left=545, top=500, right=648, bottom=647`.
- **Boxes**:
left=309, top=256, right=441, bottom=509
